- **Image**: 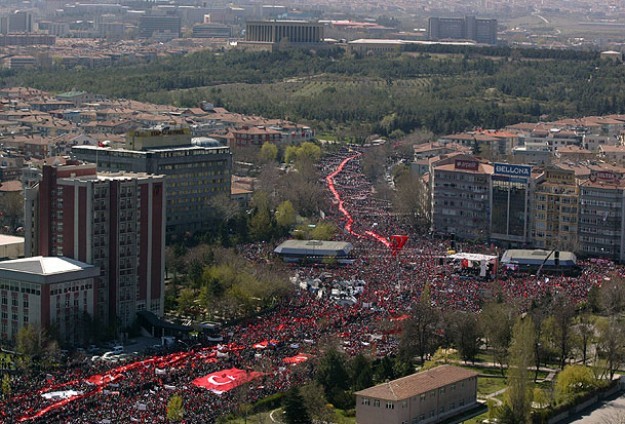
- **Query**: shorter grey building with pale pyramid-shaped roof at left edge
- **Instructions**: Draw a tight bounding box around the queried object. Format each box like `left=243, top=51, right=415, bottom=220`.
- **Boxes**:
left=0, top=256, right=100, bottom=343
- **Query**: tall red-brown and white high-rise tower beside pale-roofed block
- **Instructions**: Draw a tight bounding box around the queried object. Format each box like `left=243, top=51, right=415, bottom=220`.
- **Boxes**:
left=25, top=165, right=165, bottom=328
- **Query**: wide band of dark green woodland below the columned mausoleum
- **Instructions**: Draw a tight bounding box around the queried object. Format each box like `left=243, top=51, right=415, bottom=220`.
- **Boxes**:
left=3, top=46, right=625, bottom=137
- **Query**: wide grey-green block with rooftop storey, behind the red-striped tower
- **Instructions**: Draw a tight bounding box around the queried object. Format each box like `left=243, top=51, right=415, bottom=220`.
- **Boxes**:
left=72, top=126, right=232, bottom=238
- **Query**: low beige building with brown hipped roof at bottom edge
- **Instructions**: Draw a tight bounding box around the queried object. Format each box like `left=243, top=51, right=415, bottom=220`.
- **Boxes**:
left=355, top=365, right=478, bottom=424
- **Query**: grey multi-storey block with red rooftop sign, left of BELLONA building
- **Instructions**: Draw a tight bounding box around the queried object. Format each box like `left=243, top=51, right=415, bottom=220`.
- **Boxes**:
left=430, top=156, right=493, bottom=240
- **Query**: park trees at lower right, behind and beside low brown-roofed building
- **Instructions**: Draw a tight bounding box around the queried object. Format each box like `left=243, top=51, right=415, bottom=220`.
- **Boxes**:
left=392, top=275, right=625, bottom=423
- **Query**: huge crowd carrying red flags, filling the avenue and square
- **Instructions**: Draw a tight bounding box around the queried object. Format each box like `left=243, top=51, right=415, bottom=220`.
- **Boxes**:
left=0, top=149, right=612, bottom=423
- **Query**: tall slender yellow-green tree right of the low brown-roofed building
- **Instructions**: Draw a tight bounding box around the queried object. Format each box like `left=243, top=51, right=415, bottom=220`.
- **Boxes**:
left=506, top=316, right=534, bottom=424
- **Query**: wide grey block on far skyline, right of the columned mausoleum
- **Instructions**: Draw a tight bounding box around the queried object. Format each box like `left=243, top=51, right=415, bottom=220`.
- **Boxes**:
left=428, top=16, right=497, bottom=44
